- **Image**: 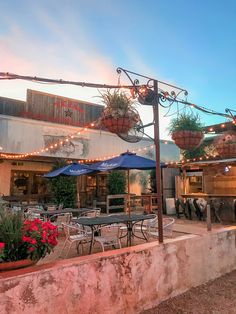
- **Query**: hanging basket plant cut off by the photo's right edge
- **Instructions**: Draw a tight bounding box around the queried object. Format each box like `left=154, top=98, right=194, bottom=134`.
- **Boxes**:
left=215, top=130, right=236, bottom=158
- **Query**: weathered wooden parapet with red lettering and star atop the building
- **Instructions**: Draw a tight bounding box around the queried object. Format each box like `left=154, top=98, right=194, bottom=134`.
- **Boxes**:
left=0, top=90, right=103, bottom=127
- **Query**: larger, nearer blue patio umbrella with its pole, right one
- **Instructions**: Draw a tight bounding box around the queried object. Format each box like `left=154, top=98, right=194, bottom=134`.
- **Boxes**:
left=90, top=152, right=156, bottom=215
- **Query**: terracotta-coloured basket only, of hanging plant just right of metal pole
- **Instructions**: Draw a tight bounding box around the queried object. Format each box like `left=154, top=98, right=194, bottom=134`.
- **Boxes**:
left=172, top=131, right=204, bottom=150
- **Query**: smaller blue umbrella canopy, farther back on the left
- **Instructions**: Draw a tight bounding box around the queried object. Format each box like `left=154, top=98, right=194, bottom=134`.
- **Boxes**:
left=44, top=163, right=94, bottom=178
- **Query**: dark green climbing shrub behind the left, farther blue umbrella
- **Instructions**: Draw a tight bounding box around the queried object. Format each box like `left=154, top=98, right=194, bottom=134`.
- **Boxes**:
left=49, top=161, right=77, bottom=208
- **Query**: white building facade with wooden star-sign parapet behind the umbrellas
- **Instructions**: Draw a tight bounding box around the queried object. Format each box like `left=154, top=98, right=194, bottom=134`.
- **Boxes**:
left=0, top=90, right=179, bottom=205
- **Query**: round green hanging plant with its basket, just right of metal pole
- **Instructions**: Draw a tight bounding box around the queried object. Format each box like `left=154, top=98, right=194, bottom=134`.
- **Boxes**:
left=169, top=113, right=203, bottom=151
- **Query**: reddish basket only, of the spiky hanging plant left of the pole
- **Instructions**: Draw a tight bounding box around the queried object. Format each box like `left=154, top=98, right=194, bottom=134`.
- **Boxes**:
left=101, top=117, right=133, bottom=133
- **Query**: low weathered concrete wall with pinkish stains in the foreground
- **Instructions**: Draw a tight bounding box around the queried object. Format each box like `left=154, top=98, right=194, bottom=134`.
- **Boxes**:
left=0, top=227, right=236, bottom=314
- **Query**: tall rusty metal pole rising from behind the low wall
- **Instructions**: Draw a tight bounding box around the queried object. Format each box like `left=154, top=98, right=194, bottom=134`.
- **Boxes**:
left=153, top=80, right=163, bottom=243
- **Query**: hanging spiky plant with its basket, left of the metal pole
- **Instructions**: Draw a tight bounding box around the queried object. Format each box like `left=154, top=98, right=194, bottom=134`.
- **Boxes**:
left=101, top=90, right=140, bottom=133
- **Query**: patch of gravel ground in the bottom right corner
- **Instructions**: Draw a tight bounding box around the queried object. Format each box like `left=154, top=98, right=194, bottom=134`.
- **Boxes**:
left=142, top=270, right=236, bottom=314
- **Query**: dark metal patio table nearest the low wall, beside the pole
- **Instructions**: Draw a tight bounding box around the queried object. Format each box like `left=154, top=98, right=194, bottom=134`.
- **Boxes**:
left=74, top=214, right=155, bottom=254
